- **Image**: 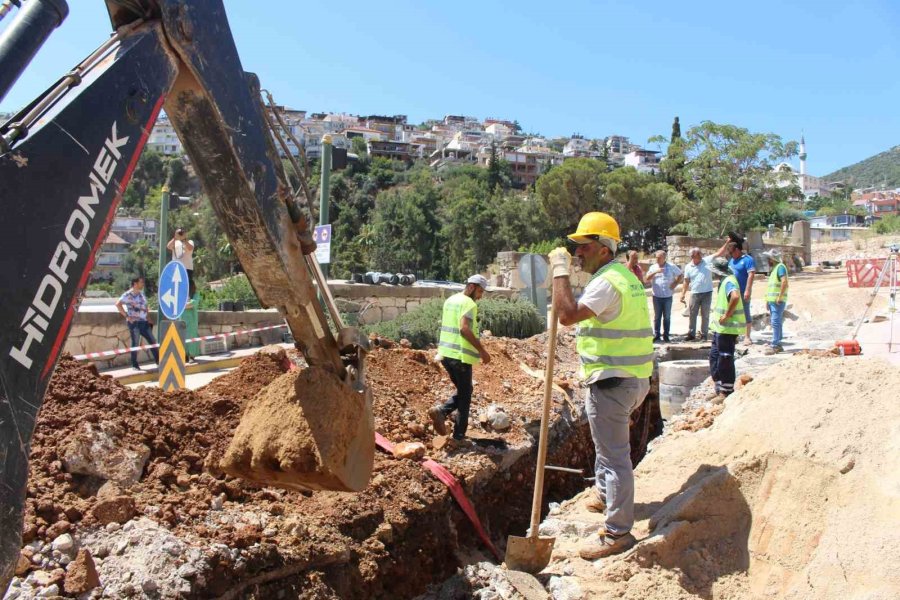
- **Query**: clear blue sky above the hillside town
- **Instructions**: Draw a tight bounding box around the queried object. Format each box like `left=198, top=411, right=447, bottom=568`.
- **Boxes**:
left=0, top=0, right=900, bottom=175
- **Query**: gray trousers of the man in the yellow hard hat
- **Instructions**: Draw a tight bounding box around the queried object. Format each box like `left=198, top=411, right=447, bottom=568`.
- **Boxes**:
left=585, top=377, right=650, bottom=535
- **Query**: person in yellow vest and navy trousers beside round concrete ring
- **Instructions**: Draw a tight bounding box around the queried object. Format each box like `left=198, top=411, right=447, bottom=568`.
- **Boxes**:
left=709, top=256, right=745, bottom=396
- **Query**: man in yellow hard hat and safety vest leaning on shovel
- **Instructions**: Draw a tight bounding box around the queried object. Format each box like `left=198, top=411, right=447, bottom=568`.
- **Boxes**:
left=550, top=212, right=653, bottom=560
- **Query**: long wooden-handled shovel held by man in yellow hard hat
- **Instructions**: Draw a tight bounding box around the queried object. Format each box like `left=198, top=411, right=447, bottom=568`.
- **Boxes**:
left=506, top=302, right=556, bottom=573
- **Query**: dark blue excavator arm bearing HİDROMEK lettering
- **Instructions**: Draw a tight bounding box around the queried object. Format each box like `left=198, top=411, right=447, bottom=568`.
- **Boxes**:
left=0, top=0, right=374, bottom=589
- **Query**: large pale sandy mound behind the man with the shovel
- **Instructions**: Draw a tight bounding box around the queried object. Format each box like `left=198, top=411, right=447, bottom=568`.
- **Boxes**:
left=542, top=356, right=900, bottom=600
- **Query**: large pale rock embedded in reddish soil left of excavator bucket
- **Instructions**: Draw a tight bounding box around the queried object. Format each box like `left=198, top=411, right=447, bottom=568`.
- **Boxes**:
left=62, top=421, right=150, bottom=487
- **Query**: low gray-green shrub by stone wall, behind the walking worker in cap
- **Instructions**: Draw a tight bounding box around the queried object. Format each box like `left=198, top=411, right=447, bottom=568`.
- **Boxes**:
left=365, top=298, right=544, bottom=349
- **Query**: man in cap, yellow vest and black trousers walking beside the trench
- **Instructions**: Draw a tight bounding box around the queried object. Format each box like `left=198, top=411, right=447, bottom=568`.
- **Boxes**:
left=428, top=275, right=491, bottom=445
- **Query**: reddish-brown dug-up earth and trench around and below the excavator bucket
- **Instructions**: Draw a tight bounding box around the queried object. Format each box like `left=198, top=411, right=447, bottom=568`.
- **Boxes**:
left=12, top=334, right=696, bottom=599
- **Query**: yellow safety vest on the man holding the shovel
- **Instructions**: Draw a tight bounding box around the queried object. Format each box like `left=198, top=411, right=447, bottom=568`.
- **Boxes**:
left=575, top=262, right=654, bottom=379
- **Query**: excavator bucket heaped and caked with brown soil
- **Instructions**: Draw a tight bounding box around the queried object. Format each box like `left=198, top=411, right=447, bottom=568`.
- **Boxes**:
left=220, top=367, right=375, bottom=492
